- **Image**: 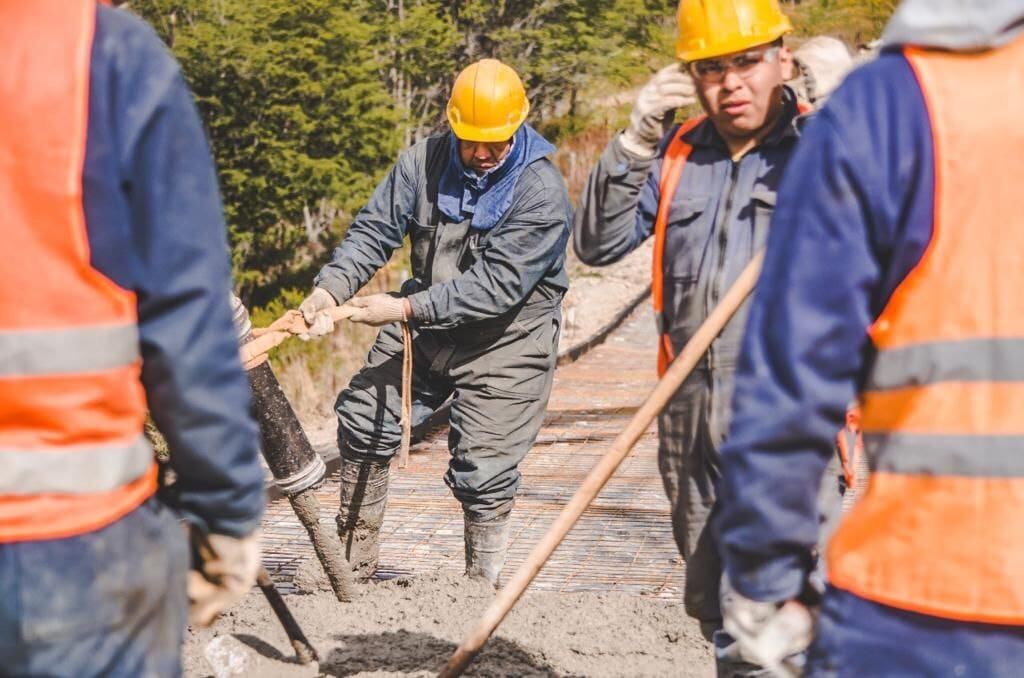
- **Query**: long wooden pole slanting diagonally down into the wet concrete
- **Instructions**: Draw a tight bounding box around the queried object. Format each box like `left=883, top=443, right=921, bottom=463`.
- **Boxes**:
left=439, top=252, right=764, bottom=678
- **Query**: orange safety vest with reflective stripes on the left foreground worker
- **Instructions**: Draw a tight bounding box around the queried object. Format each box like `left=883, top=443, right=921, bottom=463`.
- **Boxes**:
left=0, top=0, right=157, bottom=543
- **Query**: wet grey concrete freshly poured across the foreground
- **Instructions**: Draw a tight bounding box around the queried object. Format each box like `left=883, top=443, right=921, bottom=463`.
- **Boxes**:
left=184, top=575, right=714, bottom=678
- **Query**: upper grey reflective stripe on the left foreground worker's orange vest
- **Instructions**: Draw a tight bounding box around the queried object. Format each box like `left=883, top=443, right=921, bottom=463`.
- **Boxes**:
left=0, top=324, right=139, bottom=377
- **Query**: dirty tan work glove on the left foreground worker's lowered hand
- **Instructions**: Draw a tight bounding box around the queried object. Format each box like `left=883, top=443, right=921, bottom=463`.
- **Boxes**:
left=188, top=528, right=260, bottom=626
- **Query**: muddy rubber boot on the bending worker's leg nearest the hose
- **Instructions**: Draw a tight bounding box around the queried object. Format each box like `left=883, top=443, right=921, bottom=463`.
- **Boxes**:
left=337, top=458, right=391, bottom=579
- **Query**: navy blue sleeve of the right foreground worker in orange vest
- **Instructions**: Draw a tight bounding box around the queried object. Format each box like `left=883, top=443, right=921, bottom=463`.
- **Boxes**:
left=715, top=110, right=880, bottom=601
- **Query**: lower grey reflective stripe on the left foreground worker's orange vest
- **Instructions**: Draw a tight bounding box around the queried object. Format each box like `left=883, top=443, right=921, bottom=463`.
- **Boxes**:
left=0, top=435, right=154, bottom=496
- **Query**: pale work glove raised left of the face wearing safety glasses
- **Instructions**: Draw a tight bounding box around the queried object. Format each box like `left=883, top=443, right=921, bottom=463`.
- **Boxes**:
left=622, top=62, right=697, bottom=158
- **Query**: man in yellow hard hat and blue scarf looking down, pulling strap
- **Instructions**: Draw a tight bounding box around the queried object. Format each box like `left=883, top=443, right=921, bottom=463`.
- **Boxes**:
left=300, top=59, right=570, bottom=583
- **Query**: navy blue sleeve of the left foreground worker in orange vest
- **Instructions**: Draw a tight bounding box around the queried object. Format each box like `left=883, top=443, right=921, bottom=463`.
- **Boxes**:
left=82, top=6, right=263, bottom=536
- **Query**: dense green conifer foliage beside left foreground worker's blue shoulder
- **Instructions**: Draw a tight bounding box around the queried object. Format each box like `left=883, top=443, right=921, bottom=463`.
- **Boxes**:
left=133, top=0, right=399, bottom=302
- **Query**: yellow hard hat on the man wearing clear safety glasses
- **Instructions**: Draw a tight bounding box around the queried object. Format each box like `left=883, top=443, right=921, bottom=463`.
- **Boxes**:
left=676, top=0, right=793, bottom=61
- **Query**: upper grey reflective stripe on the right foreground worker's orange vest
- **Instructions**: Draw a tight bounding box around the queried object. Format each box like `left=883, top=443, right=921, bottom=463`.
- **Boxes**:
left=866, top=337, right=1024, bottom=390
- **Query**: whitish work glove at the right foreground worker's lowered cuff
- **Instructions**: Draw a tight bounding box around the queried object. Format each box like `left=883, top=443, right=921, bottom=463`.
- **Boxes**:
left=721, top=578, right=814, bottom=675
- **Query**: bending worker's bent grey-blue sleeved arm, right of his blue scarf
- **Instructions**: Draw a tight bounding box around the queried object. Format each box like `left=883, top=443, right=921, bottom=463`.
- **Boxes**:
left=409, top=166, right=570, bottom=328
